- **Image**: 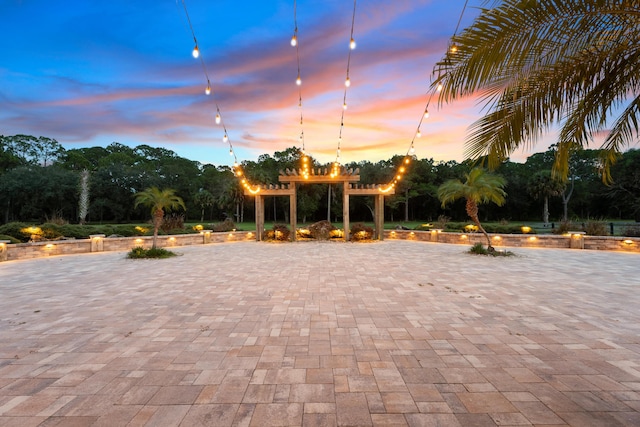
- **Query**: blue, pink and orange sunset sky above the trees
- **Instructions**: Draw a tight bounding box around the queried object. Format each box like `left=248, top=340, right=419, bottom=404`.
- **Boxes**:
left=0, top=0, right=556, bottom=165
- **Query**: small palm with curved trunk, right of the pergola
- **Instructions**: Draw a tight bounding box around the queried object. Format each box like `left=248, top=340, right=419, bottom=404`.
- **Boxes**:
left=438, top=168, right=507, bottom=252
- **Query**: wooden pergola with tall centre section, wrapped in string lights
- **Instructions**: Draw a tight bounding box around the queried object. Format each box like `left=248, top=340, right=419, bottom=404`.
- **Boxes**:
left=244, top=168, right=395, bottom=241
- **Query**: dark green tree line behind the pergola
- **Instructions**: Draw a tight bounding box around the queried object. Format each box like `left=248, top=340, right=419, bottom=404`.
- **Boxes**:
left=0, top=135, right=640, bottom=227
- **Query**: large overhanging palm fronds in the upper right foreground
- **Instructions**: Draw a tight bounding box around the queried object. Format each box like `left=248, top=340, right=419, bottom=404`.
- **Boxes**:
left=434, top=0, right=640, bottom=182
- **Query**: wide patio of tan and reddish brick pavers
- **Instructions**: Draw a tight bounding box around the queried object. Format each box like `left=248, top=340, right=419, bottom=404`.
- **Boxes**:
left=0, top=241, right=640, bottom=427
